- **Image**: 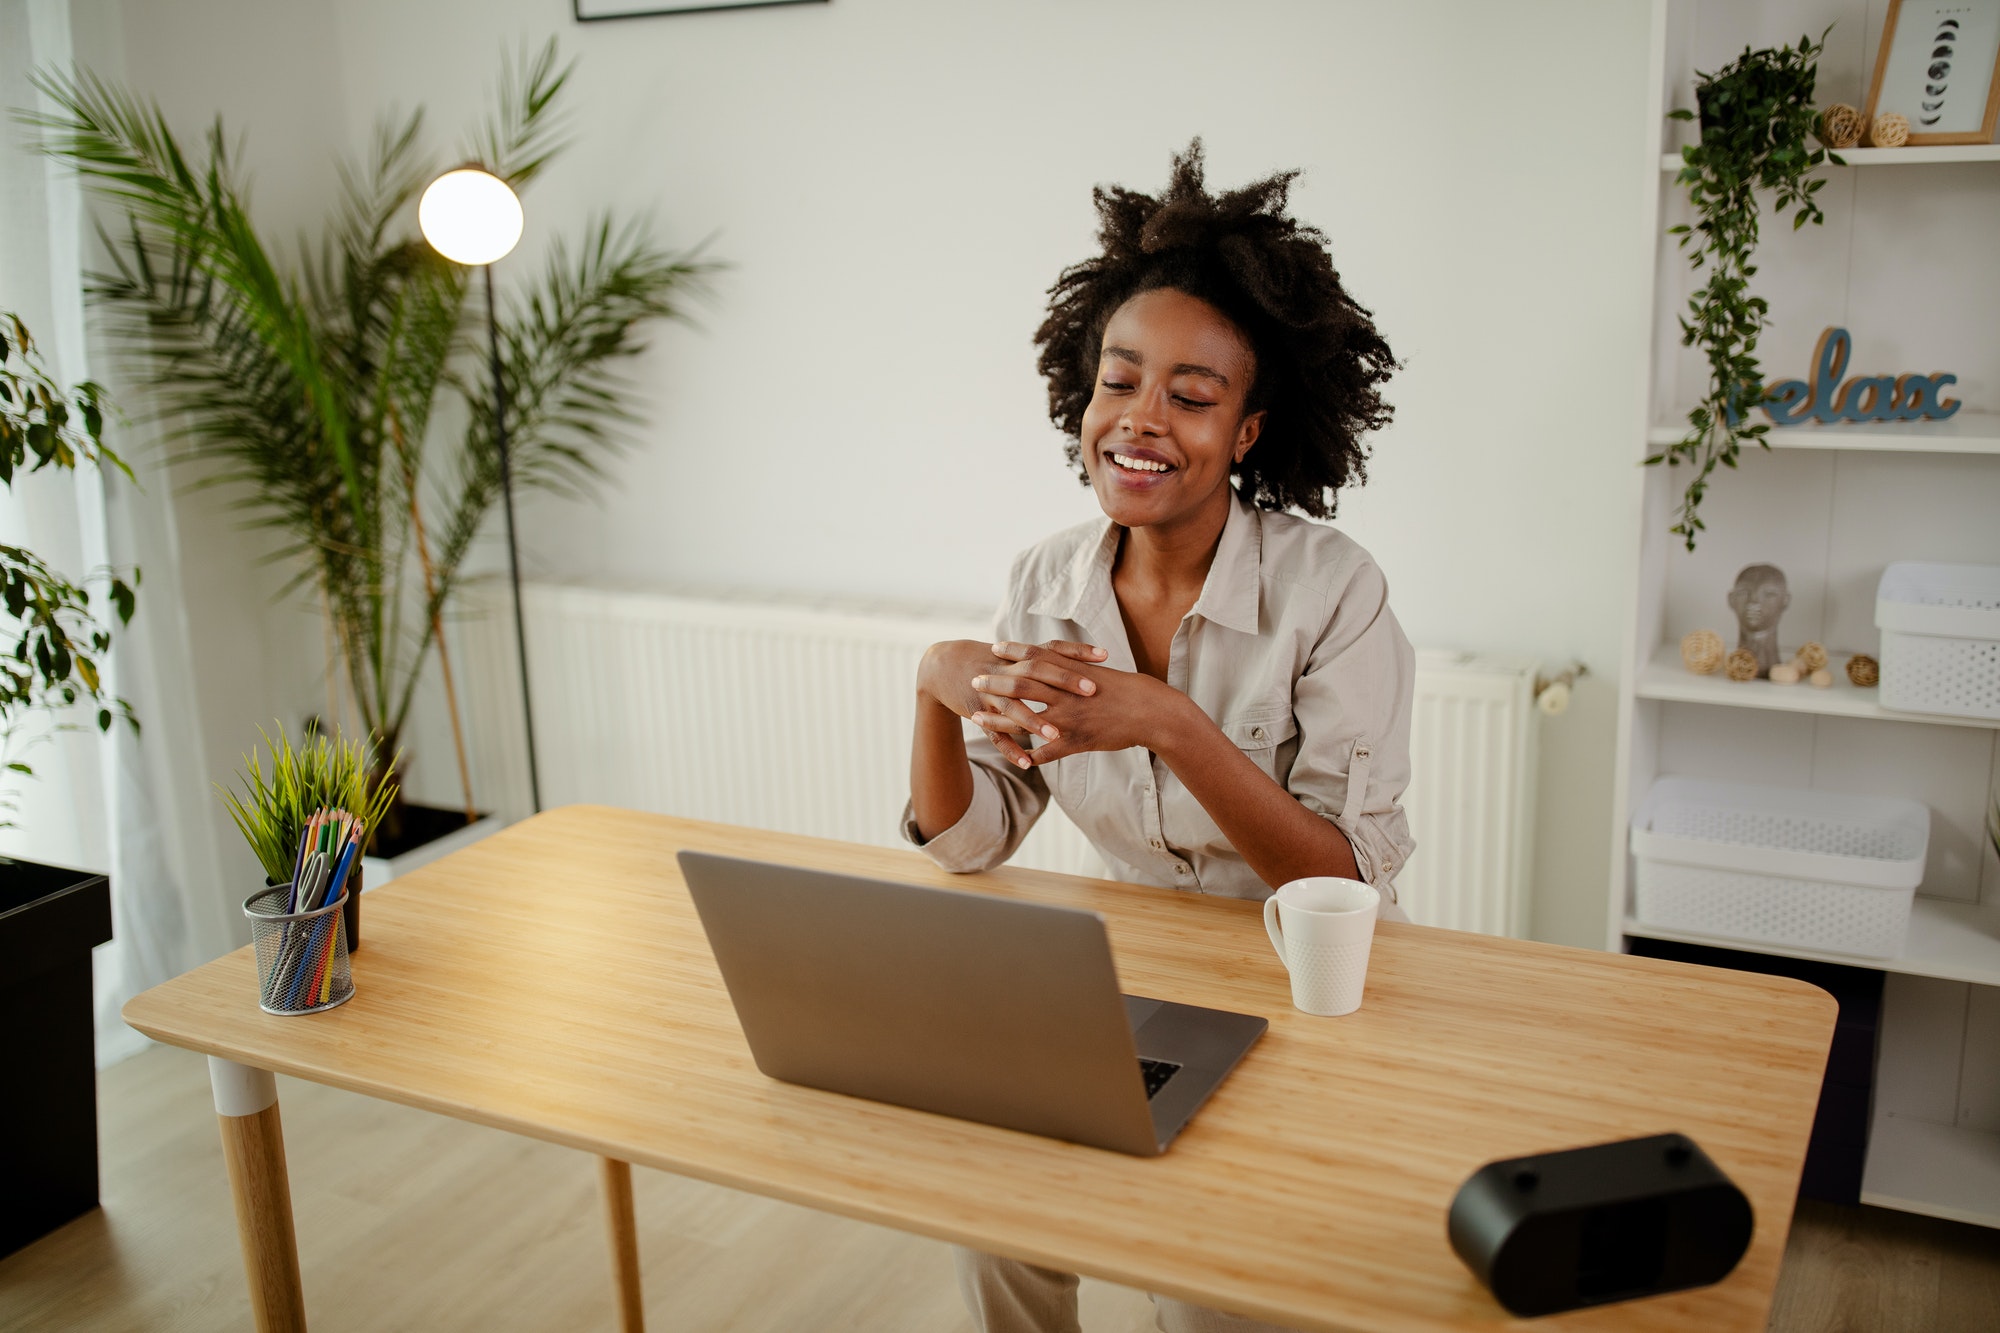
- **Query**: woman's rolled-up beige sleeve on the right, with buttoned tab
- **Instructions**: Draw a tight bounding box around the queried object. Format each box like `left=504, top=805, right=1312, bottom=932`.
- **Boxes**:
left=1286, top=560, right=1416, bottom=901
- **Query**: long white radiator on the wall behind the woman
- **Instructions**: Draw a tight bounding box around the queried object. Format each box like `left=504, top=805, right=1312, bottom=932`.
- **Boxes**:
left=454, top=584, right=1534, bottom=935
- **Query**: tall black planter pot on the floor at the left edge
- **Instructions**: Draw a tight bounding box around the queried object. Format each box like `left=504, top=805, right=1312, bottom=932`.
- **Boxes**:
left=0, top=857, right=112, bottom=1255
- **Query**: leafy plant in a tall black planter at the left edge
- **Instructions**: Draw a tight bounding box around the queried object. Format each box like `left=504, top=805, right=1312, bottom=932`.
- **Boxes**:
left=0, top=312, right=138, bottom=1255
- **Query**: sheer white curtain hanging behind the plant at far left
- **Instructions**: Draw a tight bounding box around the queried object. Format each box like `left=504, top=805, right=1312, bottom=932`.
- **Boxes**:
left=0, top=0, right=246, bottom=1067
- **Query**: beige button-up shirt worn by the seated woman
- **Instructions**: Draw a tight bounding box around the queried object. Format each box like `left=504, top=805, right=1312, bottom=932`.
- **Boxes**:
left=904, top=498, right=1416, bottom=917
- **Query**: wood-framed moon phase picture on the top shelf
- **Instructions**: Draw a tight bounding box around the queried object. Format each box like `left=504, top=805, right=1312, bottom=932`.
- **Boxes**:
left=1864, top=0, right=2000, bottom=144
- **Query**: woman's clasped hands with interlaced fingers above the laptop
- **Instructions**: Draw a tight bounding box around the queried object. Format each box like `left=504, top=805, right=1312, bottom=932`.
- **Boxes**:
left=920, top=638, right=1186, bottom=769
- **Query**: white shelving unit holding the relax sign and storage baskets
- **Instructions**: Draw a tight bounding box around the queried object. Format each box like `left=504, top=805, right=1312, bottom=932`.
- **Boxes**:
left=1608, top=0, right=2000, bottom=1227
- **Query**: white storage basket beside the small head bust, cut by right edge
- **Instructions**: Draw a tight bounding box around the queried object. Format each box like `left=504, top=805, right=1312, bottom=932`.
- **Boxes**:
left=1876, top=562, right=2000, bottom=717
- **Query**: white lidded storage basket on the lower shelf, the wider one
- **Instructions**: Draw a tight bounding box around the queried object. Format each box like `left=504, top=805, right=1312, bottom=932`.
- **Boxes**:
left=1632, top=779, right=1930, bottom=959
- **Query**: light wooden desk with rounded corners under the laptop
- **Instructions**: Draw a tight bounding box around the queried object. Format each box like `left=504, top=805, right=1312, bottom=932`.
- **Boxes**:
left=124, top=807, right=1834, bottom=1333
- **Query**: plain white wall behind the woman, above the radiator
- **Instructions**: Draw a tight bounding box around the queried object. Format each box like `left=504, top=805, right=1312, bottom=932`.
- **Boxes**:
left=78, top=0, right=1658, bottom=943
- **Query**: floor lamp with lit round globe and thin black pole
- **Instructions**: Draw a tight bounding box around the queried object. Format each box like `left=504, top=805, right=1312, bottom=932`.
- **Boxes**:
left=416, top=166, right=542, bottom=815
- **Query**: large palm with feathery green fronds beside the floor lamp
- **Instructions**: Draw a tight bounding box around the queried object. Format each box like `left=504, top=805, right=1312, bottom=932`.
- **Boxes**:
left=28, top=42, right=714, bottom=855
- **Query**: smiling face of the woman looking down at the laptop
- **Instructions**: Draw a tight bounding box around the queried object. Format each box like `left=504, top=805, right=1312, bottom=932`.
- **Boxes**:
left=1082, top=288, right=1264, bottom=528
